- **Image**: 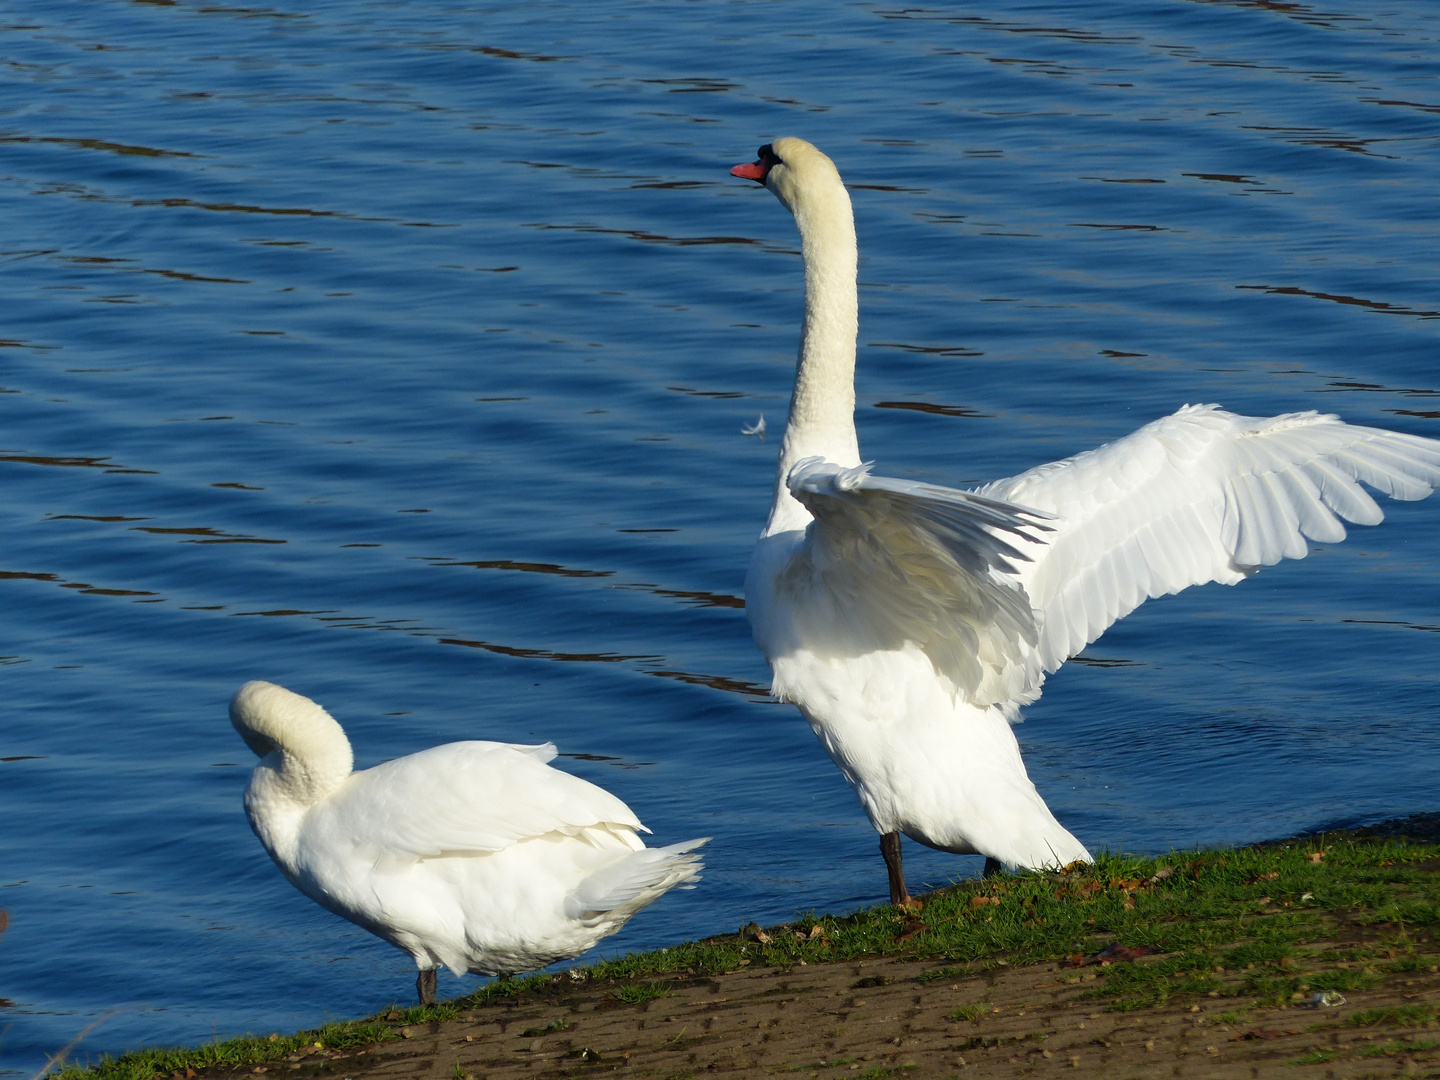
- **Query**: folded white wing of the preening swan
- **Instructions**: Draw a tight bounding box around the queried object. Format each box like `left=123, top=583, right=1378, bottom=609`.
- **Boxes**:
left=317, top=742, right=648, bottom=861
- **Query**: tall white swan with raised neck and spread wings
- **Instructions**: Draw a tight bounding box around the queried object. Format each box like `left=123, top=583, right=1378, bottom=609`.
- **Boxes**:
left=730, top=138, right=1440, bottom=904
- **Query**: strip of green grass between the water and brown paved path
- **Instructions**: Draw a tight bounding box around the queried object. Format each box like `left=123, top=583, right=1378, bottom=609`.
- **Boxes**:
left=62, top=837, right=1440, bottom=1080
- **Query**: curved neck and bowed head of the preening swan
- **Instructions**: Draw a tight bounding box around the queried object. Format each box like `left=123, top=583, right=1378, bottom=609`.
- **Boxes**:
left=230, top=680, right=354, bottom=805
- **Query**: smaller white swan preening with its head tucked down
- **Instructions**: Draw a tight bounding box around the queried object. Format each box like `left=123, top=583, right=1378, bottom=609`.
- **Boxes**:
left=230, top=681, right=706, bottom=1005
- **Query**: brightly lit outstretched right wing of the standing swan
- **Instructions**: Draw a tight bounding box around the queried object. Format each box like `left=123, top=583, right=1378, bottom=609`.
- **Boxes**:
left=981, top=405, right=1440, bottom=671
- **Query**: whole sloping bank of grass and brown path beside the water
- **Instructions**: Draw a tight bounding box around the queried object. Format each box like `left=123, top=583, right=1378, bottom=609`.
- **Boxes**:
left=62, top=815, right=1440, bottom=1080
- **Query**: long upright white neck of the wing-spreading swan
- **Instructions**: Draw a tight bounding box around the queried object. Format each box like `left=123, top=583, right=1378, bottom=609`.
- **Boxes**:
left=765, top=162, right=860, bottom=533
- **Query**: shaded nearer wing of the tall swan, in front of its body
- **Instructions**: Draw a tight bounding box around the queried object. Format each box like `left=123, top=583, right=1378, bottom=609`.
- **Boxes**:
left=778, top=458, right=1048, bottom=704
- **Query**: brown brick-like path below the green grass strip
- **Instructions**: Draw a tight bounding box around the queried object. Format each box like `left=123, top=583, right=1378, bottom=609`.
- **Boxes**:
left=240, top=959, right=1440, bottom=1080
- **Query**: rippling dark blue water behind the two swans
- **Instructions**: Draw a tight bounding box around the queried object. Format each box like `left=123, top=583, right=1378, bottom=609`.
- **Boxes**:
left=0, top=0, right=1440, bottom=1076
